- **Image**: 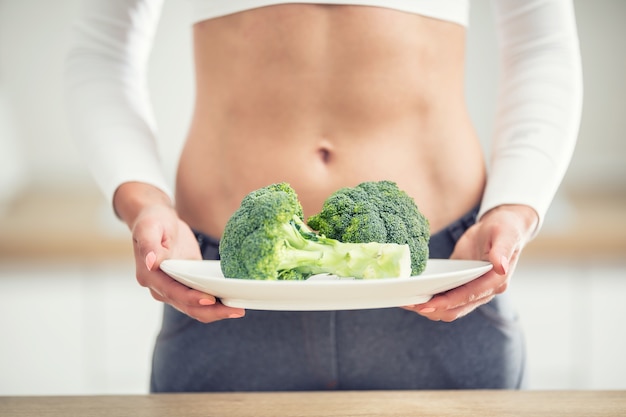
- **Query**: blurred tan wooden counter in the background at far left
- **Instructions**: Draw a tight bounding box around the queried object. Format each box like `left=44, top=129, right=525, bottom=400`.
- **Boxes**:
left=0, top=189, right=133, bottom=261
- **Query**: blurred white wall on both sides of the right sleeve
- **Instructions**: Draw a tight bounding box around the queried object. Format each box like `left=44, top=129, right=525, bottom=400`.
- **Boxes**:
left=467, top=0, right=626, bottom=191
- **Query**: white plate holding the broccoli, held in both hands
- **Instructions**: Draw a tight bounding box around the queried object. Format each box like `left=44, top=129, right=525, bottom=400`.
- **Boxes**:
left=161, top=259, right=492, bottom=311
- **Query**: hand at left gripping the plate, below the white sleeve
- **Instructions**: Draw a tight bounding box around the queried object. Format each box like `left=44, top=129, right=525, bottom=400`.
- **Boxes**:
left=115, top=183, right=245, bottom=323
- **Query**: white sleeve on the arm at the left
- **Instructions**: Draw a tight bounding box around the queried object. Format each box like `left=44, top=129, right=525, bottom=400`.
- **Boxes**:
left=65, top=0, right=172, bottom=201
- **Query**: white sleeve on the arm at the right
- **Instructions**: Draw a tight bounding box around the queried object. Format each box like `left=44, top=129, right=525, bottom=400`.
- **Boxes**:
left=478, top=0, right=582, bottom=233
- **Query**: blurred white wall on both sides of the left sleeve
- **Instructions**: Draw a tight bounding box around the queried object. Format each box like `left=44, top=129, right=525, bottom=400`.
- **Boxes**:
left=0, top=0, right=193, bottom=191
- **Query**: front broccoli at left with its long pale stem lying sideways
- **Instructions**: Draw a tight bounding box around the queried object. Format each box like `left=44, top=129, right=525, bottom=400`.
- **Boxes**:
left=219, top=183, right=411, bottom=280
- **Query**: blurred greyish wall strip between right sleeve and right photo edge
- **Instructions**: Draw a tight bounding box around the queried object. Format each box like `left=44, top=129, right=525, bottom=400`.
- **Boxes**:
left=567, top=0, right=626, bottom=191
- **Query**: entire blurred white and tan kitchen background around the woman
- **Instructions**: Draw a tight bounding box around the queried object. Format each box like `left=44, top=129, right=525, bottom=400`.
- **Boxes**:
left=0, top=0, right=626, bottom=395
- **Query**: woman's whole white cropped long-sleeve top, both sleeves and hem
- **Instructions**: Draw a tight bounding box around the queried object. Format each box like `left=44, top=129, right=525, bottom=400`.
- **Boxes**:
left=65, top=0, right=582, bottom=230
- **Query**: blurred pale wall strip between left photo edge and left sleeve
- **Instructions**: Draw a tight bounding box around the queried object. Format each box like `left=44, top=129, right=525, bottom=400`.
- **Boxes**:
left=0, top=0, right=83, bottom=188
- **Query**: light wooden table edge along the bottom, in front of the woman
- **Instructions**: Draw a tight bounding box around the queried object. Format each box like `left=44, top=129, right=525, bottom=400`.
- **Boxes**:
left=0, top=390, right=626, bottom=417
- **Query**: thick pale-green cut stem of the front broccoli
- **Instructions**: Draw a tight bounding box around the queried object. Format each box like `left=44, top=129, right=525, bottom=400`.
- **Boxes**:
left=278, top=216, right=411, bottom=279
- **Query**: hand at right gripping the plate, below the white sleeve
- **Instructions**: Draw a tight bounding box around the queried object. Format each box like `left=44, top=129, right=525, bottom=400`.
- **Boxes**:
left=404, top=205, right=538, bottom=322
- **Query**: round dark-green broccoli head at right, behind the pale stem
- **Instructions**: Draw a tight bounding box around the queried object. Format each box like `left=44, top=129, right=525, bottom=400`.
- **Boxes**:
left=307, top=181, right=430, bottom=275
